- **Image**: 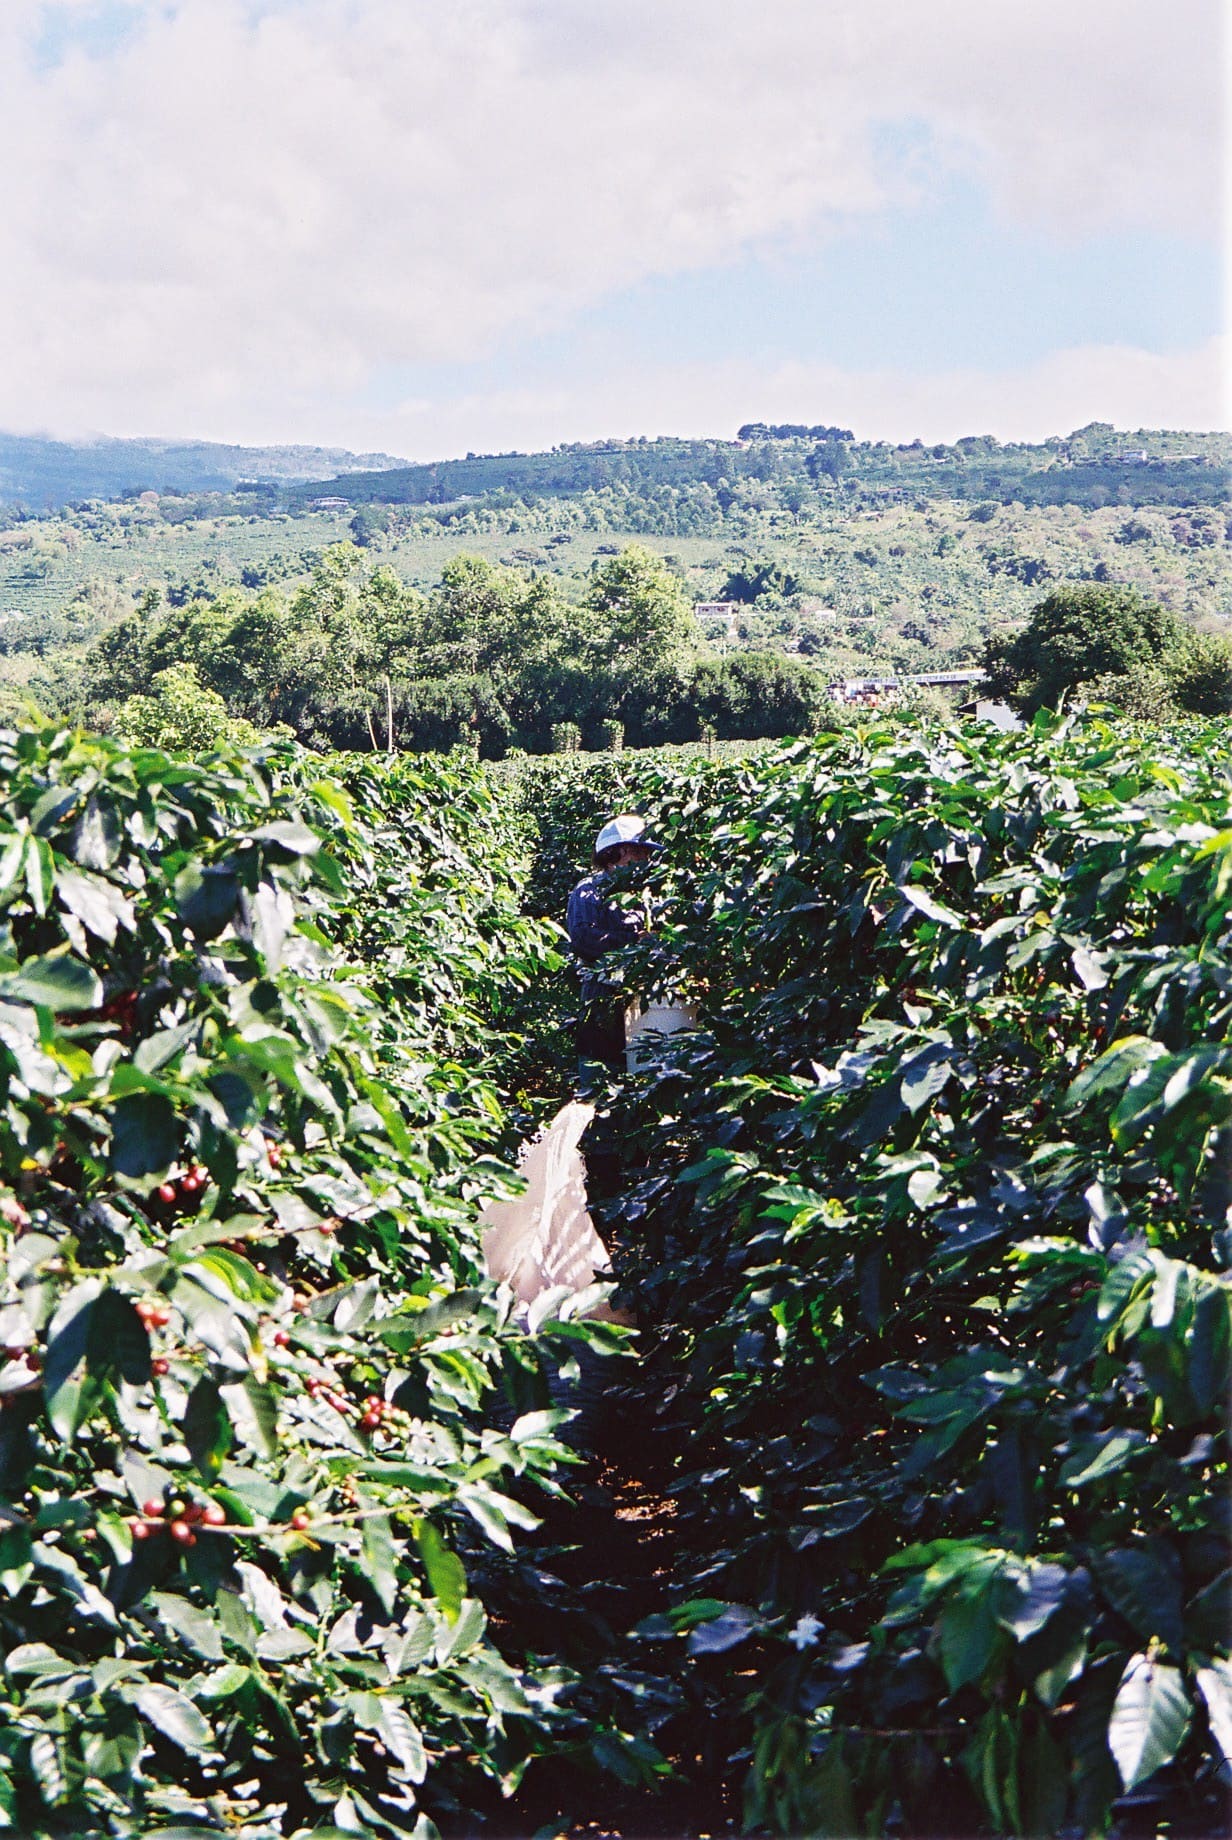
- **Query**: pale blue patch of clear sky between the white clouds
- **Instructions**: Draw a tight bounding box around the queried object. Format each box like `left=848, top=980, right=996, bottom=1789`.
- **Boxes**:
left=373, top=184, right=1223, bottom=417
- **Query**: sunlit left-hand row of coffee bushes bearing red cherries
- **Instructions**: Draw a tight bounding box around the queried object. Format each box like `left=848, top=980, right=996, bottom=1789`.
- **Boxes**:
left=0, top=730, right=605, bottom=1840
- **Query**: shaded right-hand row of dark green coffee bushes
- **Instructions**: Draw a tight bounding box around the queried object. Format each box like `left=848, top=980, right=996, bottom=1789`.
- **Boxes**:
left=507, top=716, right=1232, bottom=1834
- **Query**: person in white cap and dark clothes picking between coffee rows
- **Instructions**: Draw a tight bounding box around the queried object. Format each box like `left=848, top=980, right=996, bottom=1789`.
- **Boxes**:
left=565, top=811, right=662, bottom=1073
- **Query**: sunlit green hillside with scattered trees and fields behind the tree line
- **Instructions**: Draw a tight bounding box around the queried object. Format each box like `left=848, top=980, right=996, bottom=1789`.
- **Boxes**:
left=0, top=423, right=1232, bottom=706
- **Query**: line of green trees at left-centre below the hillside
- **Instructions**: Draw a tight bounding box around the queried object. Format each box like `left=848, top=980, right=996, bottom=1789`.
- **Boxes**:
left=44, top=543, right=827, bottom=758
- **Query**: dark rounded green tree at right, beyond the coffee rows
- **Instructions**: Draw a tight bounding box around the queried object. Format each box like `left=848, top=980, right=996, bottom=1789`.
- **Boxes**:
left=984, top=581, right=1184, bottom=714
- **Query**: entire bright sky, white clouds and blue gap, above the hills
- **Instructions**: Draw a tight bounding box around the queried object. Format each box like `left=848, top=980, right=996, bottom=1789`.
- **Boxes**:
left=0, top=0, right=1230, bottom=460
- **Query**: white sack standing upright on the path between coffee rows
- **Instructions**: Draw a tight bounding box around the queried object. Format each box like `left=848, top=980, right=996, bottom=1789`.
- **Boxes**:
left=480, top=1100, right=628, bottom=1321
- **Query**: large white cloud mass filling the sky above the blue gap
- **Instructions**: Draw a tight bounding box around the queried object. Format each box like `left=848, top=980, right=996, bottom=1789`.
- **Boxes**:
left=0, top=0, right=1219, bottom=451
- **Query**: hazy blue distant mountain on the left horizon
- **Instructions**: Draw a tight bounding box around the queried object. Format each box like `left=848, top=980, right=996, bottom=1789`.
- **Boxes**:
left=0, top=432, right=410, bottom=512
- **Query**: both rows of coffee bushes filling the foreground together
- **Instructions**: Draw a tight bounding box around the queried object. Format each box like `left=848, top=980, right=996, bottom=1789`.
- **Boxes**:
left=0, top=716, right=1232, bottom=1840
